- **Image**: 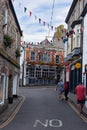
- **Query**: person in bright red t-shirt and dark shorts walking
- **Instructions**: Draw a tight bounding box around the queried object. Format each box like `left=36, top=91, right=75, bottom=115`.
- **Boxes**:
left=75, top=83, right=86, bottom=114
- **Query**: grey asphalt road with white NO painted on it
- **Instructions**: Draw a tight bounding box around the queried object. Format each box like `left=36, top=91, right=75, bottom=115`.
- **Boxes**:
left=2, top=88, right=87, bottom=130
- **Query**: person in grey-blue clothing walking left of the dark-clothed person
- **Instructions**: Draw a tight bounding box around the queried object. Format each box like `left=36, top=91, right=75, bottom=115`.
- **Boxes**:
left=56, top=79, right=64, bottom=100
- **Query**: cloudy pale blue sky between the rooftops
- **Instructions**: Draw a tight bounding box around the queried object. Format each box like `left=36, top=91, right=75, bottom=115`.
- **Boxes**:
left=13, top=0, right=73, bottom=42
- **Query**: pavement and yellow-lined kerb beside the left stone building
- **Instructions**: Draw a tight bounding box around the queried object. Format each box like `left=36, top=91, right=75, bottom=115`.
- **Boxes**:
left=0, top=96, right=25, bottom=128
